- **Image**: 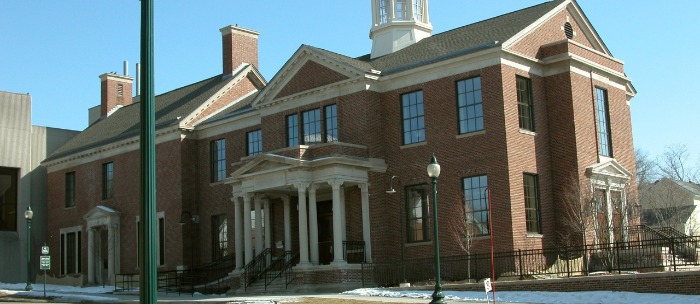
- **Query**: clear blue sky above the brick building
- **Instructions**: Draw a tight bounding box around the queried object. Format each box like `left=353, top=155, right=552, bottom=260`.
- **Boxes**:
left=0, top=0, right=700, bottom=159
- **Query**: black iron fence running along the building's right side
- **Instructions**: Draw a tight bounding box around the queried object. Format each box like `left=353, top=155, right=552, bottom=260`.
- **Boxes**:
left=362, top=236, right=700, bottom=286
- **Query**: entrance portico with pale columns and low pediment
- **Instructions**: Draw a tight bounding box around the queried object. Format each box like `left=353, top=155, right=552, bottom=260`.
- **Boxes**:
left=226, top=154, right=386, bottom=270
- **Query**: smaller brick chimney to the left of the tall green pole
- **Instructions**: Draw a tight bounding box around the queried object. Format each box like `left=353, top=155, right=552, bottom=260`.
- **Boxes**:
left=100, top=73, right=134, bottom=117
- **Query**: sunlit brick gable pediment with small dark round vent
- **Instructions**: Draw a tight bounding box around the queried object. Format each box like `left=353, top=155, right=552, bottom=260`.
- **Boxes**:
left=503, top=0, right=612, bottom=57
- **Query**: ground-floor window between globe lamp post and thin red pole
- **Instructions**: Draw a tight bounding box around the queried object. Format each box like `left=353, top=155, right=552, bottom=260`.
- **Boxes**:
left=462, top=175, right=489, bottom=237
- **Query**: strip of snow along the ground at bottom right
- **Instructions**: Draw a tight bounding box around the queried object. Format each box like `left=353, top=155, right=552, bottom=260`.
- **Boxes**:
left=343, top=288, right=700, bottom=304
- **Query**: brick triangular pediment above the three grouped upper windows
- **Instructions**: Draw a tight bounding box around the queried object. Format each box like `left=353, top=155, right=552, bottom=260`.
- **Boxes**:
left=253, top=45, right=366, bottom=108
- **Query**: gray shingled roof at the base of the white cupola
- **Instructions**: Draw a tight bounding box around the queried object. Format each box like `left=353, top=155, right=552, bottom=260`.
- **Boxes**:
left=309, top=0, right=564, bottom=75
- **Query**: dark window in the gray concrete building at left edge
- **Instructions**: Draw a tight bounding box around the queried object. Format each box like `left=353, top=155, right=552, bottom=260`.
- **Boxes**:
left=0, top=167, right=19, bottom=231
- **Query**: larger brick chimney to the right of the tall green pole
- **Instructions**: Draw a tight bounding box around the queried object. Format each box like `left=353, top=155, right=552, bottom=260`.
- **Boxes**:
left=219, top=25, right=260, bottom=74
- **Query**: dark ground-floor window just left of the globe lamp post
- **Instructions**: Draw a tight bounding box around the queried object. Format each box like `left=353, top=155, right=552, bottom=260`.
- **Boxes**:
left=406, top=185, right=429, bottom=243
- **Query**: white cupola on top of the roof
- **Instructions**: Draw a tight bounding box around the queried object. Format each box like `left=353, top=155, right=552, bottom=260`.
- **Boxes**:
left=369, top=0, right=433, bottom=58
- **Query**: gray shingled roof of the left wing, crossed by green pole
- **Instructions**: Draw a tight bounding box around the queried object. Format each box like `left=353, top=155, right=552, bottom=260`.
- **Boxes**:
left=45, top=75, right=235, bottom=161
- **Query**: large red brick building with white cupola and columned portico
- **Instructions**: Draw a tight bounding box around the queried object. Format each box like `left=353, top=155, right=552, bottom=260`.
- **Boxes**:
left=44, top=0, right=636, bottom=285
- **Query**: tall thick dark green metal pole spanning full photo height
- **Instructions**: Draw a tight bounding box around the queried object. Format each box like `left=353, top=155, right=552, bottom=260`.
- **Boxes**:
left=139, top=0, right=158, bottom=303
